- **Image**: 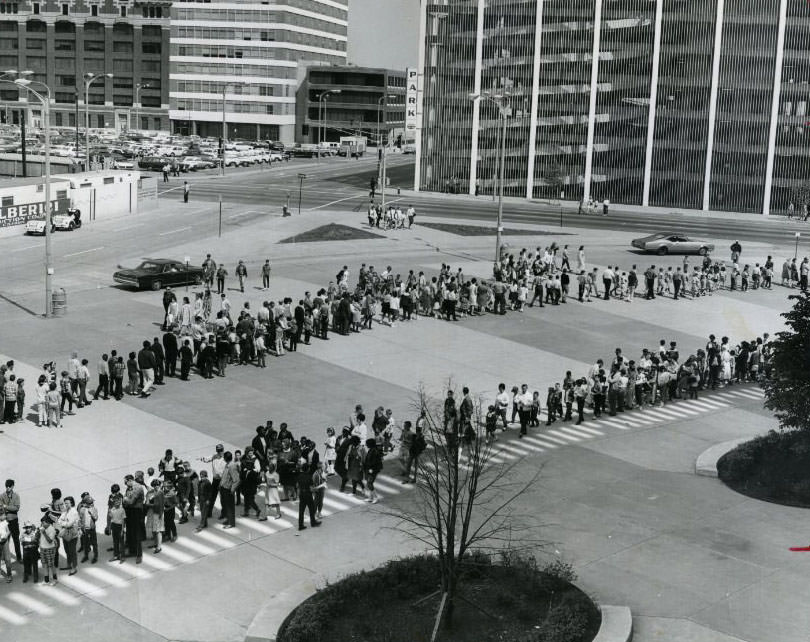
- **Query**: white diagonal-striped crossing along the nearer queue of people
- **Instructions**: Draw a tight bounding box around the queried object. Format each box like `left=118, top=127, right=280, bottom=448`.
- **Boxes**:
left=0, top=386, right=764, bottom=633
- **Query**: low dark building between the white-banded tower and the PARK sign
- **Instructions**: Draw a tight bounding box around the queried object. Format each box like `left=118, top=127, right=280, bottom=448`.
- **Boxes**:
left=295, top=66, right=405, bottom=145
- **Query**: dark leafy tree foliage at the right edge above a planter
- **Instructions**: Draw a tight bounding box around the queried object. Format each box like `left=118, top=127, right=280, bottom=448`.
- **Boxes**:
left=762, top=292, right=810, bottom=431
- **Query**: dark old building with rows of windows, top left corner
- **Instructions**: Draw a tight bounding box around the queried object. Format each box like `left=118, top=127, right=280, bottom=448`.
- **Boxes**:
left=0, top=0, right=171, bottom=131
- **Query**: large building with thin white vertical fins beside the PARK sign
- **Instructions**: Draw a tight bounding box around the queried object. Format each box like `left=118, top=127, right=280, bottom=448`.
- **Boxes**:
left=415, top=0, right=810, bottom=214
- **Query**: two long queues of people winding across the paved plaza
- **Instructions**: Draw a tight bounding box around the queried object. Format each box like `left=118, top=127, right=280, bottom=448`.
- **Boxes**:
left=0, top=245, right=776, bottom=582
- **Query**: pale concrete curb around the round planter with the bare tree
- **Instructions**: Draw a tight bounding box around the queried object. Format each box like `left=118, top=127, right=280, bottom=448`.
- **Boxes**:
left=244, top=580, right=633, bottom=642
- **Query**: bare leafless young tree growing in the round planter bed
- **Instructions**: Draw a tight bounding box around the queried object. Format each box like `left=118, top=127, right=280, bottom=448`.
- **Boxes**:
left=383, top=386, right=546, bottom=639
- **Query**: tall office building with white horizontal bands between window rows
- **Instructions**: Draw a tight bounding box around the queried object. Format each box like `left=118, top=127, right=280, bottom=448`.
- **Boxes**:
left=170, top=0, right=348, bottom=143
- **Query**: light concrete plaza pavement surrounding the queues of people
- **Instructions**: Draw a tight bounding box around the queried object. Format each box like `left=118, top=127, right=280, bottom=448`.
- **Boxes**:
left=0, top=186, right=810, bottom=642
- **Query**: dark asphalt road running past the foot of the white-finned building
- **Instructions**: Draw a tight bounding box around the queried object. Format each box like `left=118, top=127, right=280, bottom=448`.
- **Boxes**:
left=156, top=156, right=810, bottom=244
